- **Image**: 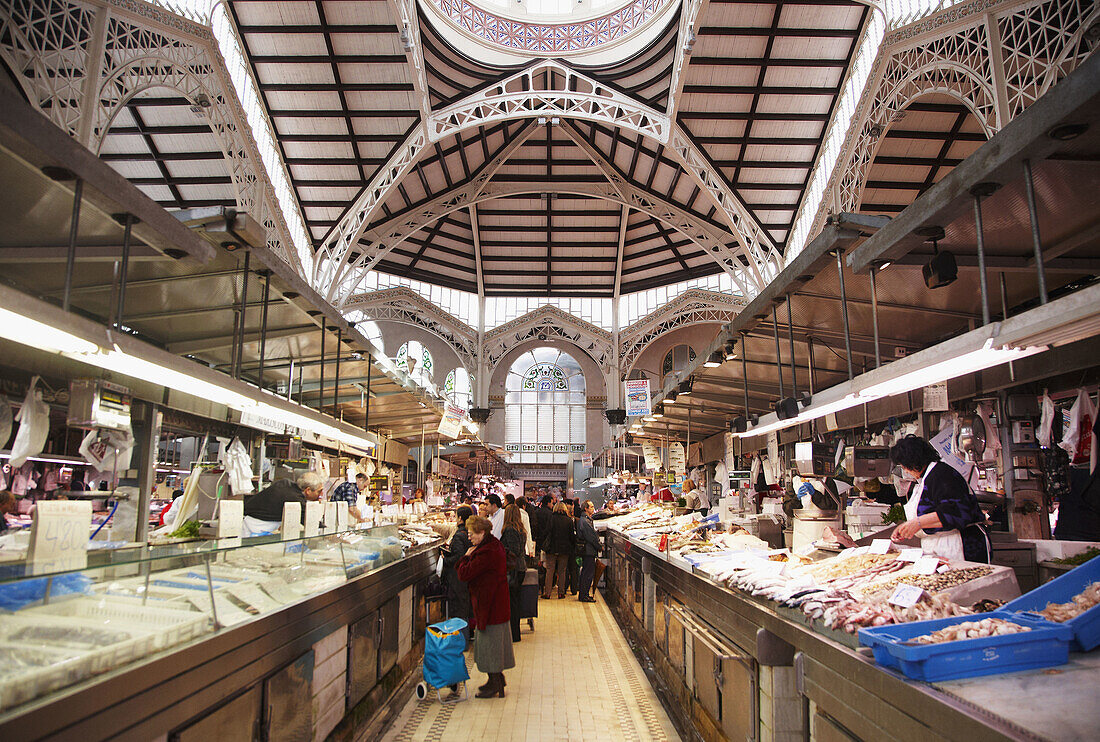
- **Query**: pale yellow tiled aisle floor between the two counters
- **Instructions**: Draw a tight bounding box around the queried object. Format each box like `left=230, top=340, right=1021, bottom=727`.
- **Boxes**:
left=383, top=596, right=680, bottom=742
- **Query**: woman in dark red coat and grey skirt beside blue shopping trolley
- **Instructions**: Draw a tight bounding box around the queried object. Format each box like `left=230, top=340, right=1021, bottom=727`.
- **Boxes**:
left=458, top=516, right=516, bottom=698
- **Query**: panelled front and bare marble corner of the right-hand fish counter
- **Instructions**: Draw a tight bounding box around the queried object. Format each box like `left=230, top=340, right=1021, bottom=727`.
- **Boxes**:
left=606, top=529, right=1095, bottom=742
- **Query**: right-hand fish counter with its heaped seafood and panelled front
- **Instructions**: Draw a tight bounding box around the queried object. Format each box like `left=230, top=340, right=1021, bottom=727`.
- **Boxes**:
left=606, top=523, right=1100, bottom=742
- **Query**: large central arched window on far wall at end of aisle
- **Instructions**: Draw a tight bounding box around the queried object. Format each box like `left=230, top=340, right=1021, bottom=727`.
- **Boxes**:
left=504, top=347, right=585, bottom=464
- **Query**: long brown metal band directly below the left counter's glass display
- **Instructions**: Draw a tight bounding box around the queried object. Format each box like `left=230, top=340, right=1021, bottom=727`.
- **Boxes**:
left=0, top=534, right=438, bottom=742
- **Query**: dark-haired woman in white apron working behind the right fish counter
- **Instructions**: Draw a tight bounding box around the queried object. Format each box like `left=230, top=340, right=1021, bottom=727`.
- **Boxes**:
left=890, top=435, right=990, bottom=564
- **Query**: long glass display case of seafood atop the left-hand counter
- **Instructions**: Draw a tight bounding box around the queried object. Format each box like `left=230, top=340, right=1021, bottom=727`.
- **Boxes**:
left=0, top=525, right=427, bottom=715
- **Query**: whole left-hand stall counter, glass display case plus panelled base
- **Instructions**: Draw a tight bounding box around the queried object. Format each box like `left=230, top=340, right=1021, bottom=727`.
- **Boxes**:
left=0, top=525, right=438, bottom=740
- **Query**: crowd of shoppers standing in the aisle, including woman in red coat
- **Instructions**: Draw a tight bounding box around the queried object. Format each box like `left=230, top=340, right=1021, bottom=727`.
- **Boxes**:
left=442, top=494, right=600, bottom=698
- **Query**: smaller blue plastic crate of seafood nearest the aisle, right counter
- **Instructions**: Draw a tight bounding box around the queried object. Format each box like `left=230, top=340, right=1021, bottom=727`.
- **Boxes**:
left=859, top=611, right=1073, bottom=683
